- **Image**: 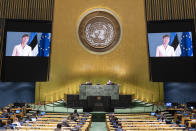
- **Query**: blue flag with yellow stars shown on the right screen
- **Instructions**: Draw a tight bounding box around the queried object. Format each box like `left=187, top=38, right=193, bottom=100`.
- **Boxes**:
left=180, top=32, right=193, bottom=56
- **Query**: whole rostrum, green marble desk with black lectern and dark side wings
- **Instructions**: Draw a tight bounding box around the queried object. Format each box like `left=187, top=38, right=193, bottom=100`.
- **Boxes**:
left=67, top=85, right=131, bottom=112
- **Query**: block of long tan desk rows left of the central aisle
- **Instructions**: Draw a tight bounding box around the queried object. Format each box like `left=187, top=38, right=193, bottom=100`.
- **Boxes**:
left=17, top=113, right=92, bottom=131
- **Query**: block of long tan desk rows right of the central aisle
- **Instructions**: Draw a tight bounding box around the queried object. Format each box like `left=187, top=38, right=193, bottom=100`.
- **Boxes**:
left=106, top=114, right=185, bottom=131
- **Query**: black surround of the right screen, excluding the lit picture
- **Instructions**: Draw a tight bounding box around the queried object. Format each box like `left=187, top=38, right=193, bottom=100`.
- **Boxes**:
left=146, top=19, right=196, bottom=82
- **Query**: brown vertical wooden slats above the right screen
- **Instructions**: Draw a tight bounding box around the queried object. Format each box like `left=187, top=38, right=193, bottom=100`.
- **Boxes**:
left=145, top=0, right=196, bottom=31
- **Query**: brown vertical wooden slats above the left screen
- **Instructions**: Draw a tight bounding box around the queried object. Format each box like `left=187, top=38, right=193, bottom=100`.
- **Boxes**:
left=0, top=0, right=54, bottom=20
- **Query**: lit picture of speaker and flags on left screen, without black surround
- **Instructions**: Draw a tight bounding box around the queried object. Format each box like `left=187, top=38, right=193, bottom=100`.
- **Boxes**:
left=6, top=32, right=51, bottom=57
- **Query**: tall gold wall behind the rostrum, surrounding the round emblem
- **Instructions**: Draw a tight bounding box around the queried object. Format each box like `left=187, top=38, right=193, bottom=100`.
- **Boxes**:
left=36, top=0, right=163, bottom=102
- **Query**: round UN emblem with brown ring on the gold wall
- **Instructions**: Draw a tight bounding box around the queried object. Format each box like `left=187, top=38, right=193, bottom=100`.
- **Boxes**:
left=77, top=9, right=121, bottom=53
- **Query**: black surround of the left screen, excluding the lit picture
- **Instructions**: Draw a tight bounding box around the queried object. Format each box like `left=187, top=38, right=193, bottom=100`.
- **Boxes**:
left=1, top=19, right=53, bottom=82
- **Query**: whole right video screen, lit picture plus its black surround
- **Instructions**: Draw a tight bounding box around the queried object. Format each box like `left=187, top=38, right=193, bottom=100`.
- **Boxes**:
left=147, top=19, right=196, bottom=82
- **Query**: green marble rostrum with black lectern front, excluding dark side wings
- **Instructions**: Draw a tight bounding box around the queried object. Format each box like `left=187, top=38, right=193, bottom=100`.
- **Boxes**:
left=79, top=84, right=119, bottom=112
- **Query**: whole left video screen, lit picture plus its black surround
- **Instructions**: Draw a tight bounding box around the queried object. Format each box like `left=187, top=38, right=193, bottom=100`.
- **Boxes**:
left=1, top=19, right=52, bottom=82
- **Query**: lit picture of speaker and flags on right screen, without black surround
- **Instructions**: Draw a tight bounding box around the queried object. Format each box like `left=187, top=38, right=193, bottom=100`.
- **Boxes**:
left=148, top=32, right=193, bottom=57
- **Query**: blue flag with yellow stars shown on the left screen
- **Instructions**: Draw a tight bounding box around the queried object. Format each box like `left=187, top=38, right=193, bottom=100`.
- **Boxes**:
left=38, top=33, right=50, bottom=56
